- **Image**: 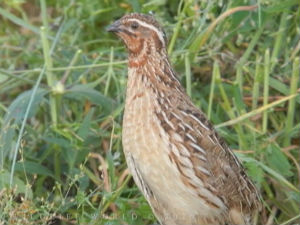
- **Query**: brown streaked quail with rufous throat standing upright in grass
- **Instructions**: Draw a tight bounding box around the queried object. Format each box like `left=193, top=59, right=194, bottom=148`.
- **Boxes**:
left=108, top=13, right=260, bottom=225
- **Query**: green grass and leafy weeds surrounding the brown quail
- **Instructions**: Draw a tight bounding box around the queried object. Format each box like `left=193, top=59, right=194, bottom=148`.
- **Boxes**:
left=0, top=0, right=300, bottom=225
